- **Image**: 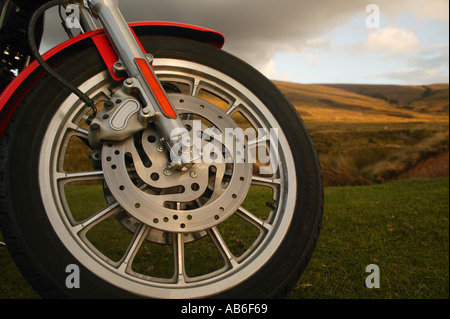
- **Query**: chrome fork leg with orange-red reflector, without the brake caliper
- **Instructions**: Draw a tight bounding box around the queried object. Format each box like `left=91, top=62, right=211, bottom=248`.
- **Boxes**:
left=87, top=0, right=188, bottom=165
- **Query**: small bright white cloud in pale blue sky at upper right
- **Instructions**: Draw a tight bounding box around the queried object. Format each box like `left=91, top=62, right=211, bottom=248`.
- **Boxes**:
left=365, top=27, right=420, bottom=53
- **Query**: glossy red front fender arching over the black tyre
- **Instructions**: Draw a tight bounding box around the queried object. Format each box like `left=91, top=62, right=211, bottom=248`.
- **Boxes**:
left=0, top=22, right=225, bottom=138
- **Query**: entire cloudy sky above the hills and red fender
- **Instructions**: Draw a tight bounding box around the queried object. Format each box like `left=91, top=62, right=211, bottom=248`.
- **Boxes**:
left=41, top=0, right=449, bottom=85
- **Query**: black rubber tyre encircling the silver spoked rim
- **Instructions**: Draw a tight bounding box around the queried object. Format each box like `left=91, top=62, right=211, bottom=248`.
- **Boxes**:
left=0, top=36, right=323, bottom=298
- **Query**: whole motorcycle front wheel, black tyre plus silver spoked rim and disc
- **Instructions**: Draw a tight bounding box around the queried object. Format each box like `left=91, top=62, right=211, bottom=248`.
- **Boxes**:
left=0, top=36, right=323, bottom=299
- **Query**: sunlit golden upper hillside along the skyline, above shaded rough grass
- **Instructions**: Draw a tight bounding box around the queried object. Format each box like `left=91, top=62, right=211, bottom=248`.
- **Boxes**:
left=274, top=81, right=449, bottom=123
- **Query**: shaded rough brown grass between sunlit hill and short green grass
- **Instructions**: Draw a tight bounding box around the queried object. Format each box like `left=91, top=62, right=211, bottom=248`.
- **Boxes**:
left=312, top=124, right=449, bottom=186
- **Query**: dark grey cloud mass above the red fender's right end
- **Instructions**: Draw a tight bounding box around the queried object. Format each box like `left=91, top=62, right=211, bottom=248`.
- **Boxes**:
left=118, top=0, right=366, bottom=65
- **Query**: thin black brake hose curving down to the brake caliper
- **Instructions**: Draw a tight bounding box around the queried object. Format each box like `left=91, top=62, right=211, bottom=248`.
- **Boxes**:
left=28, top=0, right=97, bottom=117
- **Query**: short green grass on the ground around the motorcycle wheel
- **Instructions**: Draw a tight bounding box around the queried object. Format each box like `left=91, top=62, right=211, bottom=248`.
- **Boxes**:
left=0, top=178, right=449, bottom=299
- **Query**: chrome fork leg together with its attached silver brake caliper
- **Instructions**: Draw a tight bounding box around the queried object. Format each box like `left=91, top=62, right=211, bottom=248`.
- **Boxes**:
left=87, top=0, right=189, bottom=168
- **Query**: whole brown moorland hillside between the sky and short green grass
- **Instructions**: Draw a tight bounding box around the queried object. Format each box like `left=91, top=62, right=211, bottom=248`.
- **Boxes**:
left=274, top=82, right=449, bottom=186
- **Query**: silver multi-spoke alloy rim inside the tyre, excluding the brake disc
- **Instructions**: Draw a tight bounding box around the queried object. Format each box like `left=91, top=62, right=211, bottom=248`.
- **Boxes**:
left=39, top=59, right=296, bottom=298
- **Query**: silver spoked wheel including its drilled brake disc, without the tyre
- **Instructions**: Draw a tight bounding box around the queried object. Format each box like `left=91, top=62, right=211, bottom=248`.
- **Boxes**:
left=40, top=59, right=296, bottom=298
